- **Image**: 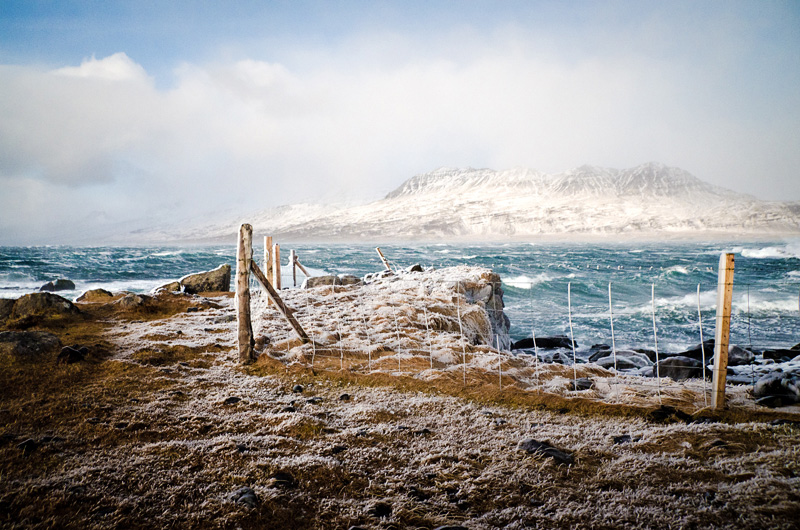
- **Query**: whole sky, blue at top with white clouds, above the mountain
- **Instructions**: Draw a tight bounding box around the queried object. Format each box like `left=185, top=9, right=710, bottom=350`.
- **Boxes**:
left=0, top=0, right=800, bottom=244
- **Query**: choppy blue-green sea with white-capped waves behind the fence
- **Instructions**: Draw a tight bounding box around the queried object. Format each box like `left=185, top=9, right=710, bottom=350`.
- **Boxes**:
left=0, top=241, right=800, bottom=351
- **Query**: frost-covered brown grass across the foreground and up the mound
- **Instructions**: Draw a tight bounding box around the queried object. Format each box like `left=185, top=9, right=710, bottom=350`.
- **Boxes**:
left=0, top=270, right=800, bottom=529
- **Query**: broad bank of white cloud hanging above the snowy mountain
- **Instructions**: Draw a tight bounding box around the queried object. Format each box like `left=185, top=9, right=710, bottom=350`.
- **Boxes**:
left=0, top=26, right=800, bottom=243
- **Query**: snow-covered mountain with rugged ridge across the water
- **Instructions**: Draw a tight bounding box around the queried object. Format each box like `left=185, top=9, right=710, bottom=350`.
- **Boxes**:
left=141, top=163, right=800, bottom=241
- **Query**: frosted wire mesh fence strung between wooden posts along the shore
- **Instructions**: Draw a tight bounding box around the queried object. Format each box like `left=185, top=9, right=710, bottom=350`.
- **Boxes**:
left=247, top=264, right=800, bottom=408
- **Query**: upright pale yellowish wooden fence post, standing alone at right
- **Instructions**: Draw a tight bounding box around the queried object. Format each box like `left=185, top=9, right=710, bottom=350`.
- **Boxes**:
left=716, top=254, right=733, bottom=410
